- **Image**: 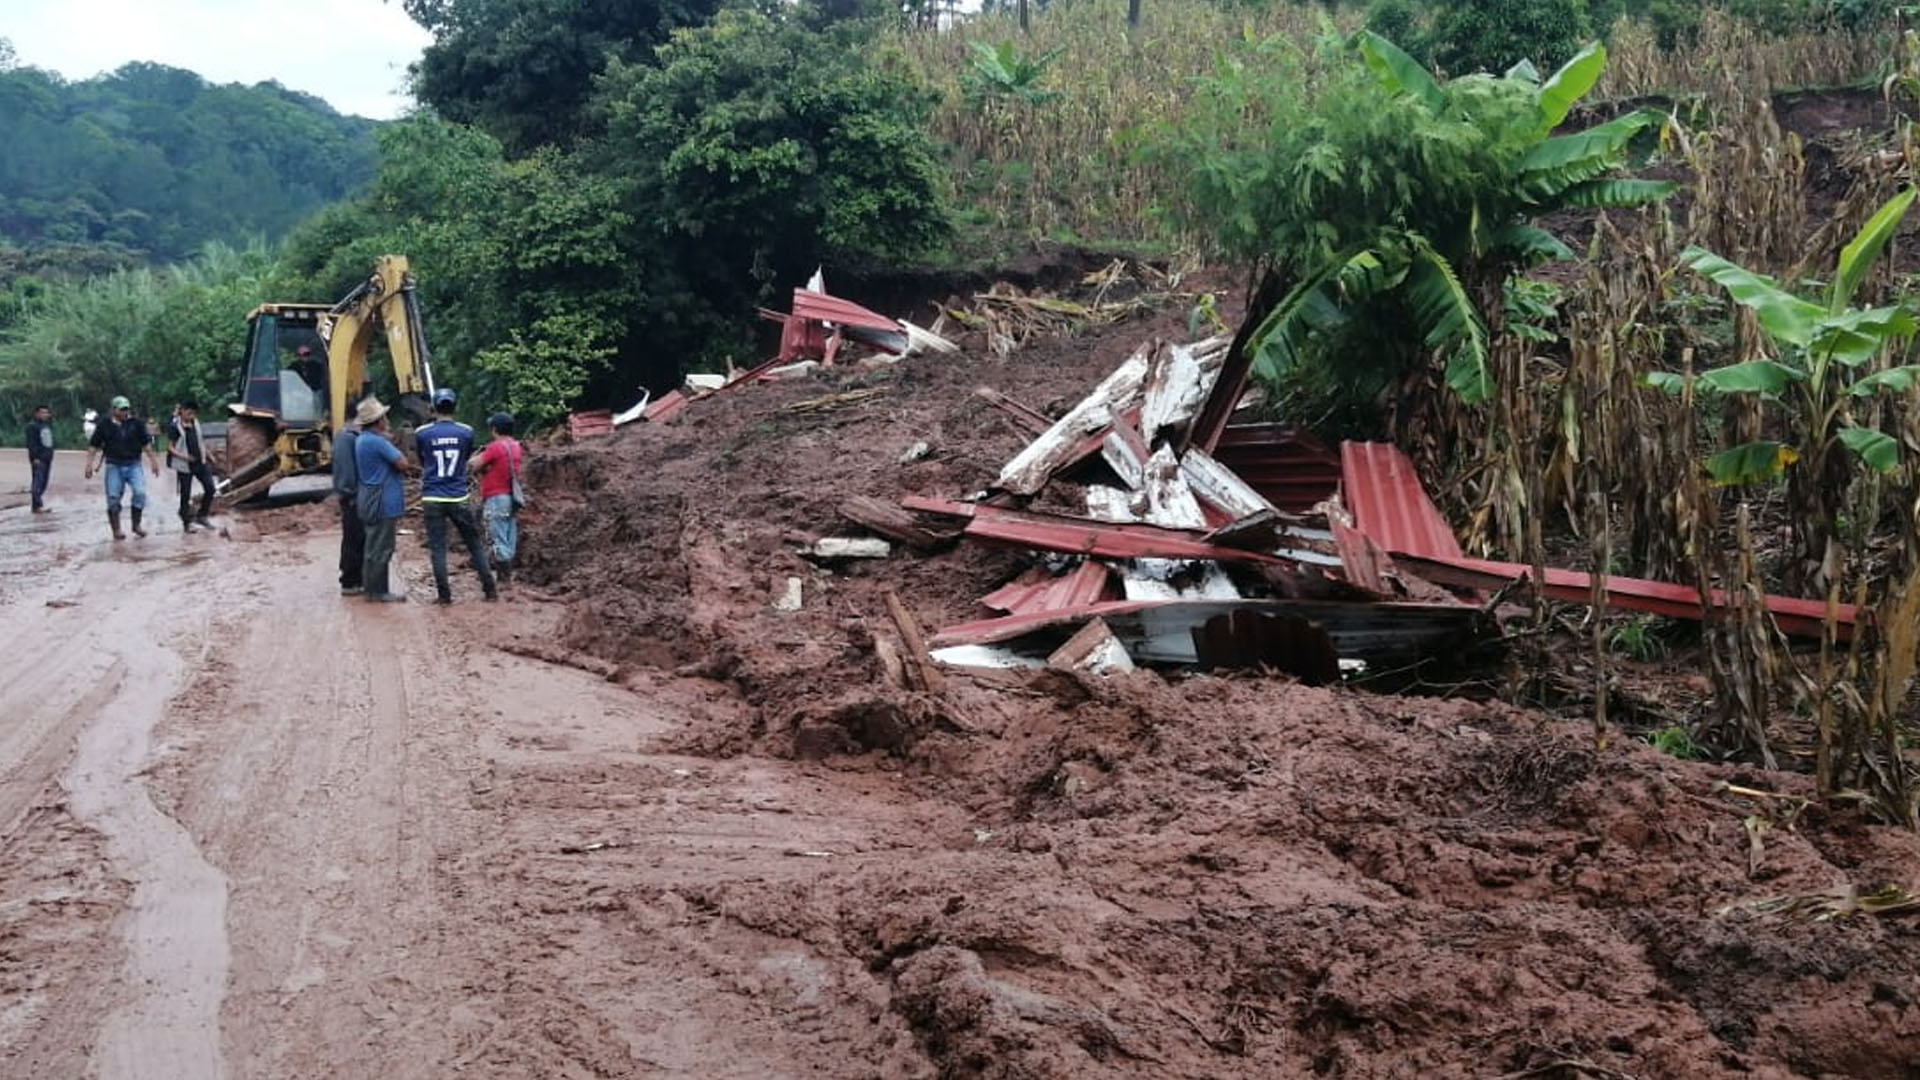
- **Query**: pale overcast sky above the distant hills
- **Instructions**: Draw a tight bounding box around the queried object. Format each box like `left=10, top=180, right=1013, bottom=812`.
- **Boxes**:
left=0, top=0, right=432, bottom=119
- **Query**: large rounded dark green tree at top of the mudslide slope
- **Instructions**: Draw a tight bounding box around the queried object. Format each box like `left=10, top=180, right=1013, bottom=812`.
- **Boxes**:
left=593, top=10, right=948, bottom=380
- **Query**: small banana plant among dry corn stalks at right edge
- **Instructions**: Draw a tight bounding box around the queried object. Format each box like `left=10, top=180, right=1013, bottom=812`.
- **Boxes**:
left=1647, top=188, right=1920, bottom=486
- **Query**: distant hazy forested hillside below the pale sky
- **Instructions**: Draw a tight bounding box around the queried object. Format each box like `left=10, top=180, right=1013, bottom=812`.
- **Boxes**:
left=0, top=48, right=376, bottom=270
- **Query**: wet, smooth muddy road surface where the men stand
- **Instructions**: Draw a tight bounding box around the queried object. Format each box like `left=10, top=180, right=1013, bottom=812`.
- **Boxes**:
left=0, top=455, right=937, bottom=1078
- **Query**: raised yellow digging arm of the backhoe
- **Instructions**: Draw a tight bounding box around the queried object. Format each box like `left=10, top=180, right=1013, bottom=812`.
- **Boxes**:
left=321, top=256, right=434, bottom=430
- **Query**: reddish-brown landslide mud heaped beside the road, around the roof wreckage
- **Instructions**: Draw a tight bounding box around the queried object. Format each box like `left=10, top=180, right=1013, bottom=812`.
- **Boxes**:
left=526, top=284, right=1920, bottom=1076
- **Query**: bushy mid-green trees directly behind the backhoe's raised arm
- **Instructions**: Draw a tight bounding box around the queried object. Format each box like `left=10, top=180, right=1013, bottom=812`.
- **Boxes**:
left=280, top=115, right=637, bottom=427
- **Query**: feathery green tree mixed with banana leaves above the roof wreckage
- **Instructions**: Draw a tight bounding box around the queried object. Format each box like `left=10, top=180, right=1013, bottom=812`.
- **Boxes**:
left=1162, top=31, right=1672, bottom=417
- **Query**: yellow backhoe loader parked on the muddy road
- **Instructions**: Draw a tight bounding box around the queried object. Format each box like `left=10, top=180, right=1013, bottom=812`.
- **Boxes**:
left=221, top=256, right=434, bottom=503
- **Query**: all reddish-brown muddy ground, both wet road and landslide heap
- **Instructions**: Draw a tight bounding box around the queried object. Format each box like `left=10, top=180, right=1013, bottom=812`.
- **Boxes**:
left=0, top=278, right=1920, bottom=1078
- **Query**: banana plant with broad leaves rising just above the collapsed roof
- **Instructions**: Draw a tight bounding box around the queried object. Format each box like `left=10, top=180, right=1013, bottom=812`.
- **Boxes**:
left=1248, top=31, right=1674, bottom=404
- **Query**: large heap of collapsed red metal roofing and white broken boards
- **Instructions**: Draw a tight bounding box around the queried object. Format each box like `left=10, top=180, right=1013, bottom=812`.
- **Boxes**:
left=871, top=338, right=1853, bottom=682
